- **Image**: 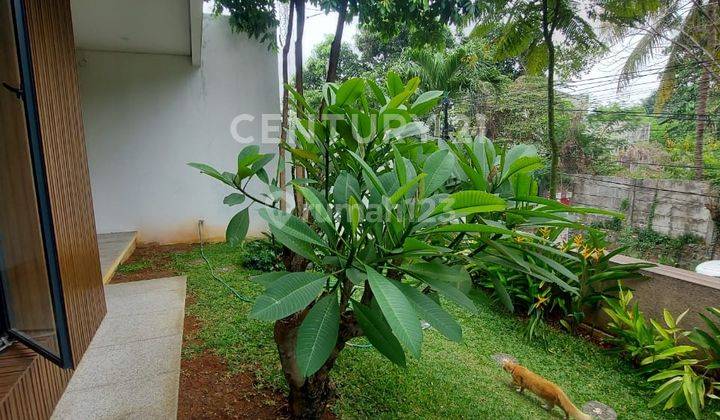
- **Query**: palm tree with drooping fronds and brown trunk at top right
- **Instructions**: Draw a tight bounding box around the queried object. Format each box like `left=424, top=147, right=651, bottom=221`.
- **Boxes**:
left=606, top=0, right=720, bottom=180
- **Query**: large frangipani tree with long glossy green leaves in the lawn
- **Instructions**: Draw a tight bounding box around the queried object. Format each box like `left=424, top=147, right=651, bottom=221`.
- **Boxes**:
left=191, top=74, right=506, bottom=418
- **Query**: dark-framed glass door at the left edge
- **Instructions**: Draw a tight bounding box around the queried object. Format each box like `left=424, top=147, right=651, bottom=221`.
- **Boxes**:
left=0, top=0, right=72, bottom=367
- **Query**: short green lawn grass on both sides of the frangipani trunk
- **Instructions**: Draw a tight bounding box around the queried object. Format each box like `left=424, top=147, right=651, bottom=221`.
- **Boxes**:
left=173, top=244, right=717, bottom=419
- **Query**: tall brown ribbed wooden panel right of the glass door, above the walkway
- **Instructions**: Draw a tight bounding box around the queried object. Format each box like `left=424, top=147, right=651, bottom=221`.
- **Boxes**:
left=25, top=0, right=105, bottom=364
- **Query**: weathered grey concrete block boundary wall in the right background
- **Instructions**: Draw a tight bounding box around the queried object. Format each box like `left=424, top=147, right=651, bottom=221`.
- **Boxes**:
left=570, top=174, right=715, bottom=243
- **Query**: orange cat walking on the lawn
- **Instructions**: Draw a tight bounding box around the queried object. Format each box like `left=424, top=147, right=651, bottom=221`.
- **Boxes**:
left=503, top=361, right=592, bottom=420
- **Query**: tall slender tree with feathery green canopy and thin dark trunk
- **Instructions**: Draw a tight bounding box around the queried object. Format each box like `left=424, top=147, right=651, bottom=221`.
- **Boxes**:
left=474, top=0, right=604, bottom=197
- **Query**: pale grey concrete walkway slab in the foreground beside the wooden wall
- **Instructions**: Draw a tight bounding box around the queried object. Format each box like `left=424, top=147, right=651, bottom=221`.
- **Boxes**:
left=52, top=277, right=186, bottom=420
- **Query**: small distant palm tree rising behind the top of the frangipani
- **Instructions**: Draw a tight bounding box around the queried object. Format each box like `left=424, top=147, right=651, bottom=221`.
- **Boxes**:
left=404, top=48, right=474, bottom=140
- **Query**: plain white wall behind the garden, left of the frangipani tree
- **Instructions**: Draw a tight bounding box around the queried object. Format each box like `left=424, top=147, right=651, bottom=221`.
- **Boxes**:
left=78, top=16, right=279, bottom=243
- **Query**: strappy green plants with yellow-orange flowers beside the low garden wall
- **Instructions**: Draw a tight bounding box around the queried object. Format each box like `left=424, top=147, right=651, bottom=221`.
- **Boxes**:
left=480, top=226, right=652, bottom=338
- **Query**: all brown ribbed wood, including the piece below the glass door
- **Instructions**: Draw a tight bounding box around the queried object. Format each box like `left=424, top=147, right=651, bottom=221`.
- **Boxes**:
left=0, top=0, right=106, bottom=420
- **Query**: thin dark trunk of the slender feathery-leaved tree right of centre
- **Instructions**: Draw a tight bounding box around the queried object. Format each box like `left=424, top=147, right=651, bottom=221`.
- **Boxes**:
left=542, top=0, right=560, bottom=200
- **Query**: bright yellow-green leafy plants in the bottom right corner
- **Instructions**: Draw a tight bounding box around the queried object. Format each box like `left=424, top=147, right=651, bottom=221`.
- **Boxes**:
left=603, top=289, right=720, bottom=419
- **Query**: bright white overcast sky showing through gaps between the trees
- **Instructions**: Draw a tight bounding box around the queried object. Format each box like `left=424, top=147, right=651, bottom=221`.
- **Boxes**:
left=204, top=2, right=664, bottom=107
